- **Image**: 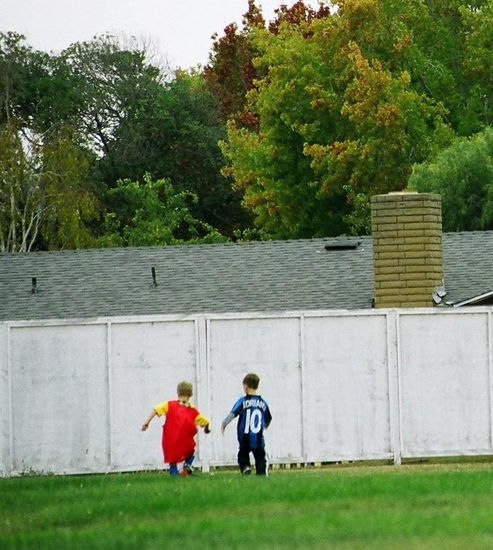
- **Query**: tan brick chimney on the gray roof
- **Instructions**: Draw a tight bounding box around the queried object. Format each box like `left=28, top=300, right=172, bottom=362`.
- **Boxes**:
left=371, top=192, right=443, bottom=308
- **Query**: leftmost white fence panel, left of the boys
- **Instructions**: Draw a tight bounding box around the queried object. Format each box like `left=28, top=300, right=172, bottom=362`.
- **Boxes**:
left=10, top=325, right=109, bottom=472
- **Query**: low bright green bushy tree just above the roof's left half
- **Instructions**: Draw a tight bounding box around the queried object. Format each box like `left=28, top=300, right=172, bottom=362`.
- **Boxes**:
left=99, top=174, right=226, bottom=246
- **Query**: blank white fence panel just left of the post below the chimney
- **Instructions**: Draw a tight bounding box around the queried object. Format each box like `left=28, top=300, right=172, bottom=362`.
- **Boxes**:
left=304, top=315, right=391, bottom=461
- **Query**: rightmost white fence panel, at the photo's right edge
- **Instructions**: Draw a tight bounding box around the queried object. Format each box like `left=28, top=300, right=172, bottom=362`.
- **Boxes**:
left=400, top=312, right=492, bottom=457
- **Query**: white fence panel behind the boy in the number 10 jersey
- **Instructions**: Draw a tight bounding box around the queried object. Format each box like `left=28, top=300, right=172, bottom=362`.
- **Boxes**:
left=208, top=317, right=302, bottom=464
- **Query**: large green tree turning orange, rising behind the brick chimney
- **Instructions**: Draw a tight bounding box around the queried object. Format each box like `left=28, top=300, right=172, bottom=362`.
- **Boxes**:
left=222, top=0, right=449, bottom=238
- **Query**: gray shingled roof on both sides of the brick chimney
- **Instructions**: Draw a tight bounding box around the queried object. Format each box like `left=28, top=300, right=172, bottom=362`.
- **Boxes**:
left=0, top=231, right=493, bottom=320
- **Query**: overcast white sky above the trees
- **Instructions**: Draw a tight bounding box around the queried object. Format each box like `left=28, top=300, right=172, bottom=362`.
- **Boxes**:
left=0, top=0, right=318, bottom=68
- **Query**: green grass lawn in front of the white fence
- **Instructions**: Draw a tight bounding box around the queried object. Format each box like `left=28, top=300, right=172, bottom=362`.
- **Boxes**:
left=0, top=463, right=493, bottom=550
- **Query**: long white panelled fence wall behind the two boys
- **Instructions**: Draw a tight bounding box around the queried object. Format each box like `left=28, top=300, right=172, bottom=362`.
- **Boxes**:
left=0, top=308, right=493, bottom=476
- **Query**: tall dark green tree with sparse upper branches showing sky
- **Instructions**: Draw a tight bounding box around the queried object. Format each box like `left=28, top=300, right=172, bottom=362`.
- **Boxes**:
left=59, top=35, right=250, bottom=239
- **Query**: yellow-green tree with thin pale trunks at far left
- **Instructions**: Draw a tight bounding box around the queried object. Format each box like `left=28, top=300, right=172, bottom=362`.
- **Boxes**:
left=0, top=122, right=99, bottom=252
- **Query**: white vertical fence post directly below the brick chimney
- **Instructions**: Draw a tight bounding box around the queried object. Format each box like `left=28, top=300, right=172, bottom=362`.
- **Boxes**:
left=386, top=310, right=402, bottom=466
